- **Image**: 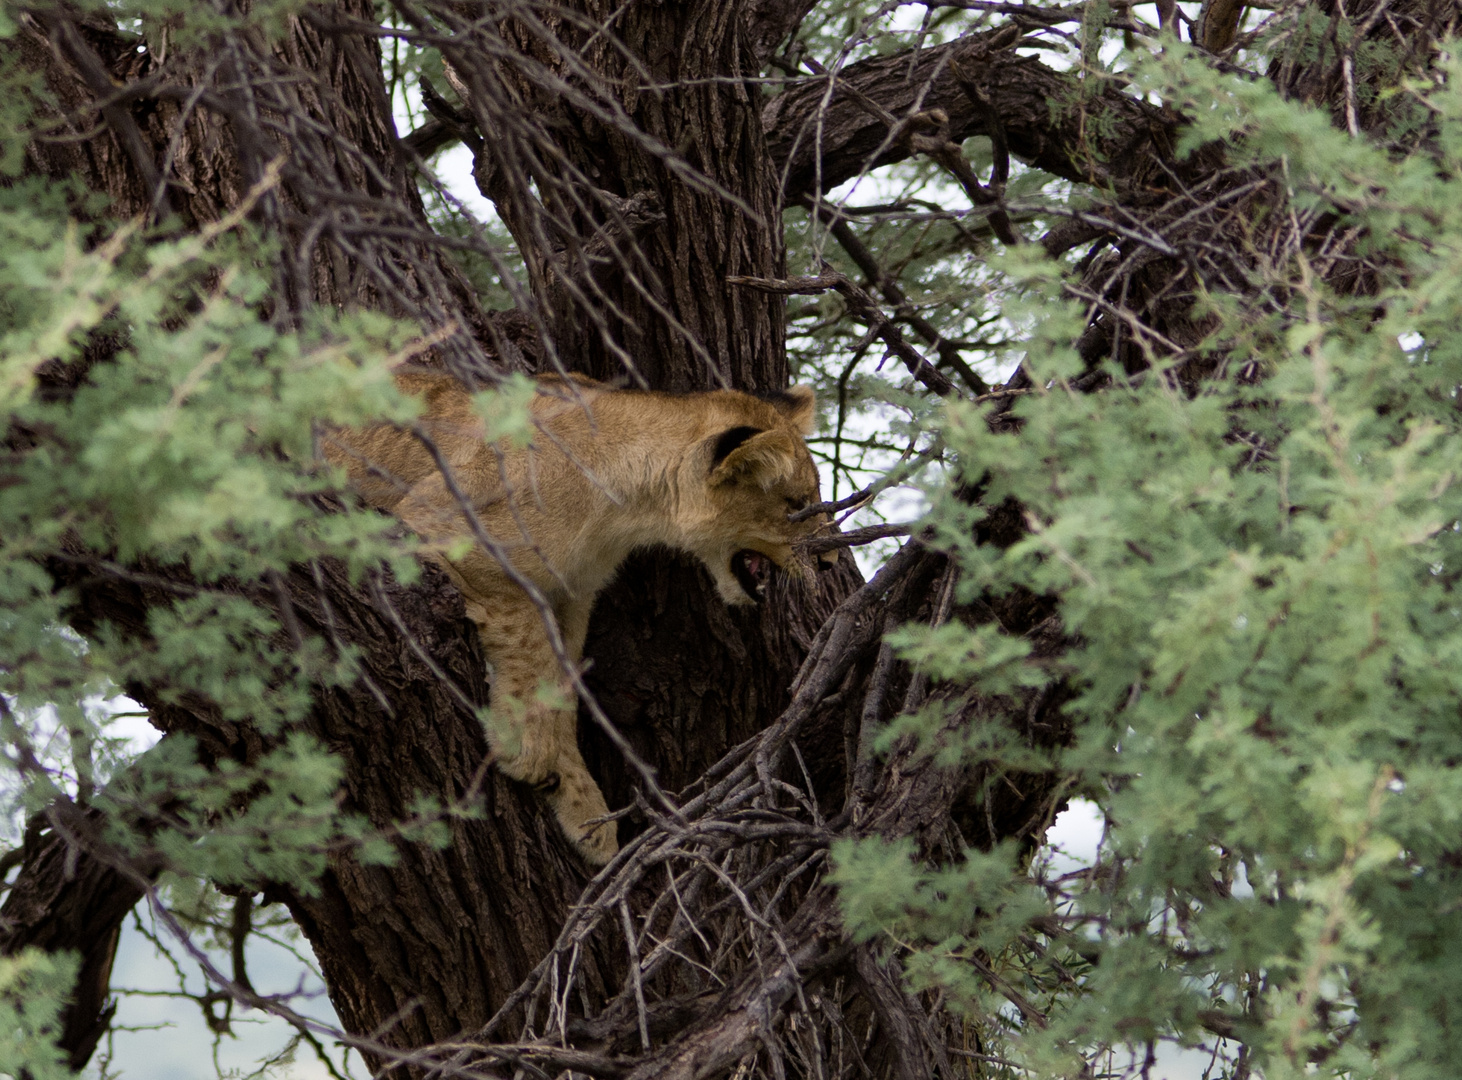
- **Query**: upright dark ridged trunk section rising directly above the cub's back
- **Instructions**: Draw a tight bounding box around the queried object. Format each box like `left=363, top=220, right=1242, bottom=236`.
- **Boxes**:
left=443, top=0, right=787, bottom=390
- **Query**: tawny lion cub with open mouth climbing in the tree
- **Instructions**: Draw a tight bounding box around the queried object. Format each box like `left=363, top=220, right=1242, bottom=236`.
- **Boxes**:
left=329, top=373, right=836, bottom=864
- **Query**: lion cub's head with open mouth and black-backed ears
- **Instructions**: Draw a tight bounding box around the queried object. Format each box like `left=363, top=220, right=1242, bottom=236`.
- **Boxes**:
left=689, top=386, right=838, bottom=604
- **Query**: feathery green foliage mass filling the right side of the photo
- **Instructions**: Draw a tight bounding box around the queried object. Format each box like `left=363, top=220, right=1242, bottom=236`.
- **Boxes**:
left=835, top=44, right=1462, bottom=1080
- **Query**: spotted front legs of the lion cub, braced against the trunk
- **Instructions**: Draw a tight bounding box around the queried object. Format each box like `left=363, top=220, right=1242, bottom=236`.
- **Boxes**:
left=468, top=589, right=618, bottom=865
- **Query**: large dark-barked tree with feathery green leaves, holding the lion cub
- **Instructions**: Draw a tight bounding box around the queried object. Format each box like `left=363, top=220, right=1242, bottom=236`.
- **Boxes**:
left=0, top=0, right=1462, bottom=1077
